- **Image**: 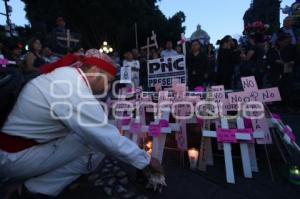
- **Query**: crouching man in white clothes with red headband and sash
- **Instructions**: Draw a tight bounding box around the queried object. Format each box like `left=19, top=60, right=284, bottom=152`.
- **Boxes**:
left=0, top=50, right=162, bottom=196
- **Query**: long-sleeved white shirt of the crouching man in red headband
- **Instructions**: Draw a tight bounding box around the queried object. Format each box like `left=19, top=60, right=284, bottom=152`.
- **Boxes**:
left=2, top=67, right=150, bottom=169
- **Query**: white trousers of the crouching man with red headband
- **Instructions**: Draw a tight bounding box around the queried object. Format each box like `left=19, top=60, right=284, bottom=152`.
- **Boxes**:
left=0, top=134, right=104, bottom=196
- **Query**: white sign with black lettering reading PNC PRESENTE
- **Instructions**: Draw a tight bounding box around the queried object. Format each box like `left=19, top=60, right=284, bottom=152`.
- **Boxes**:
left=148, top=55, right=187, bottom=88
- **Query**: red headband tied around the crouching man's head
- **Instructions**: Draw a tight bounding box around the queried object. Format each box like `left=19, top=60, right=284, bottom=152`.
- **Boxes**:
left=40, top=54, right=117, bottom=76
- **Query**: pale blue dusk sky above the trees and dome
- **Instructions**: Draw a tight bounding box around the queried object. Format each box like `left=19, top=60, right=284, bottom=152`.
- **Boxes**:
left=0, top=0, right=295, bottom=43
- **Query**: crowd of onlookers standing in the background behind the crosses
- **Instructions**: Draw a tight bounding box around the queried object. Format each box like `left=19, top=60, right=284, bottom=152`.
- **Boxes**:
left=0, top=17, right=300, bottom=109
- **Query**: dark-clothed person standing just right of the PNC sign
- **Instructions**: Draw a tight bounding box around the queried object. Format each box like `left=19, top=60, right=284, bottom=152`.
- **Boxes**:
left=187, top=40, right=209, bottom=90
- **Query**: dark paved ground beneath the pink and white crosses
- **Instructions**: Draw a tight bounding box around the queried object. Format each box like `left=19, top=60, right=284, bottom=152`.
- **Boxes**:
left=56, top=111, right=300, bottom=199
